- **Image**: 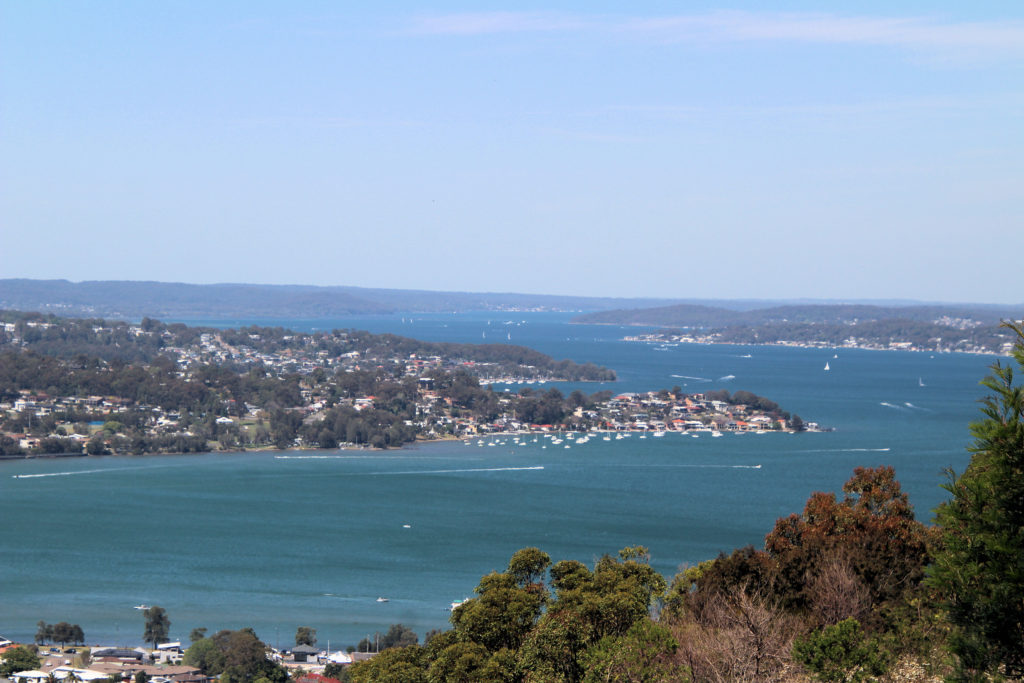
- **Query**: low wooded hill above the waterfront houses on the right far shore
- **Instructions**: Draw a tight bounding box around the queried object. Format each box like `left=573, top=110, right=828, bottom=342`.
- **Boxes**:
left=572, top=304, right=1024, bottom=329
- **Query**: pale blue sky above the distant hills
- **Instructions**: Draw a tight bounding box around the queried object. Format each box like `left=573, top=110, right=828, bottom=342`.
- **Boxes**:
left=0, top=0, right=1024, bottom=303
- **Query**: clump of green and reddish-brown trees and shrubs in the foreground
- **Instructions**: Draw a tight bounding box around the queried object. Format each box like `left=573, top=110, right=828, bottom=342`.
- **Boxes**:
left=349, top=467, right=950, bottom=683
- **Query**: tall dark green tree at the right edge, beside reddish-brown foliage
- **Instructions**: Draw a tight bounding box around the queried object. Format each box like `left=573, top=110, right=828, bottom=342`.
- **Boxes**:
left=929, top=324, right=1024, bottom=681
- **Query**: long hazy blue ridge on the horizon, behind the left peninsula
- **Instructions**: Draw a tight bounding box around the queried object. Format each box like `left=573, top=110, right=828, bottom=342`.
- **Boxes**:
left=0, top=280, right=678, bottom=319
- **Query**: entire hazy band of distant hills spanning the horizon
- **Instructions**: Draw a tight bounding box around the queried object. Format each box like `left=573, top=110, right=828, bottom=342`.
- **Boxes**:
left=0, top=279, right=1024, bottom=327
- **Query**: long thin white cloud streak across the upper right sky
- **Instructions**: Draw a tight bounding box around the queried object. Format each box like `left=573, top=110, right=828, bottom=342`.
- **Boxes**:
left=410, top=11, right=1024, bottom=54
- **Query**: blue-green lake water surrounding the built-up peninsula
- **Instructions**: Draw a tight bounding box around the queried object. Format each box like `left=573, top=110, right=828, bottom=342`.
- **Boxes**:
left=0, top=313, right=992, bottom=647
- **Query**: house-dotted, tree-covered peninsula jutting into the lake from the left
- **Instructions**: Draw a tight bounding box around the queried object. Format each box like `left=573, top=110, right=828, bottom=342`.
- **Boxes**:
left=0, top=311, right=816, bottom=456
